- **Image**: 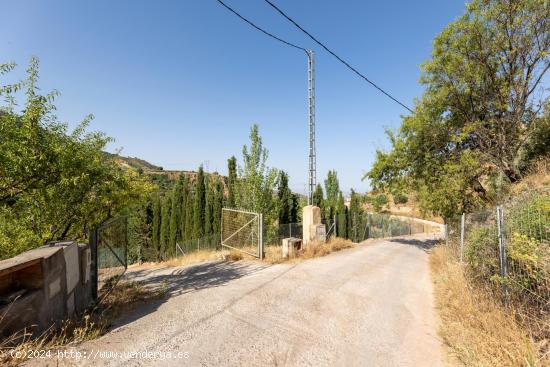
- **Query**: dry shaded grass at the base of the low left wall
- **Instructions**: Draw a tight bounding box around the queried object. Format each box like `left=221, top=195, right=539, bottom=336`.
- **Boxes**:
left=0, top=282, right=165, bottom=367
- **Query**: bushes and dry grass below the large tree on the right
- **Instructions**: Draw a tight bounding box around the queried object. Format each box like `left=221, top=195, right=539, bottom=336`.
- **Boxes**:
left=431, top=179, right=550, bottom=366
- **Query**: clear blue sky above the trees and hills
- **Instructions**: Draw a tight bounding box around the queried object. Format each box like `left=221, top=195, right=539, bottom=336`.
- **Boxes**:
left=0, top=0, right=464, bottom=193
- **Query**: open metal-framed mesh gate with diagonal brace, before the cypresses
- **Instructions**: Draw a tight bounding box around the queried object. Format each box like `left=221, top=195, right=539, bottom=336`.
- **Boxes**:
left=221, top=208, right=264, bottom=259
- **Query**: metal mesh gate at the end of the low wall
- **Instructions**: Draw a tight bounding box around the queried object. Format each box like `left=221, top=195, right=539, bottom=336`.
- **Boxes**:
left=90, top=216, right=128, bottom=299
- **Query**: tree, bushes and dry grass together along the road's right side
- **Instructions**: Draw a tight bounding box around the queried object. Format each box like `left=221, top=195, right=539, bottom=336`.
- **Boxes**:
left=365, top=0, right=550, bottom=366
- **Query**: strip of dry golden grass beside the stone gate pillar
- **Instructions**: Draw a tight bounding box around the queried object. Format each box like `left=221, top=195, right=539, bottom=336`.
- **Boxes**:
left=265, top=238, right=355, bottom=264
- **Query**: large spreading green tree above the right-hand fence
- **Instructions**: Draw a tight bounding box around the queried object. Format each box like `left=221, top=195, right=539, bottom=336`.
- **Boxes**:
left=366, top=0, right=550, bottom=217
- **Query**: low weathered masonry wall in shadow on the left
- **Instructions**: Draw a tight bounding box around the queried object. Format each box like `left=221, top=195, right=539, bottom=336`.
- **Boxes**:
left=0, top=242, right=92, bottom=336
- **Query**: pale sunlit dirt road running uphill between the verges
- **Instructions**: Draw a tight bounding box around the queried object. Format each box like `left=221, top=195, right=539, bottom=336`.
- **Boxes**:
left=40, top=236, right=442, bottom=366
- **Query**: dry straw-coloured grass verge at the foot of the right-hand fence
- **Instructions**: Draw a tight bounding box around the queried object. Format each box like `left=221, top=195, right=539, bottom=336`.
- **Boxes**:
left=430, top=246, right=549, bottom=366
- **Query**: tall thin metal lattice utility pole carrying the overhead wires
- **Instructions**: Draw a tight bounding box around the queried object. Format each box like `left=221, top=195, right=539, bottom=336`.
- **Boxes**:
left=306, top=50, right=317, bottom=205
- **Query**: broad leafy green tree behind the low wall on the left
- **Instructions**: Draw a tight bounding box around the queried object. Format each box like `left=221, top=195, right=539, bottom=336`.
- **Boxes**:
left=0, top=59, right=152, bottom=259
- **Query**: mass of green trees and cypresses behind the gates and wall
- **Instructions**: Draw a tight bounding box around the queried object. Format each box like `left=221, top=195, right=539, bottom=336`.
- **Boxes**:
left=0, top=58, right=370, bottom=264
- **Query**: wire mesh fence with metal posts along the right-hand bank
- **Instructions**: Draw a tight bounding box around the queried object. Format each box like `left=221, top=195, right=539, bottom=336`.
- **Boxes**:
left=446, top=193, right=550, bottom=338
